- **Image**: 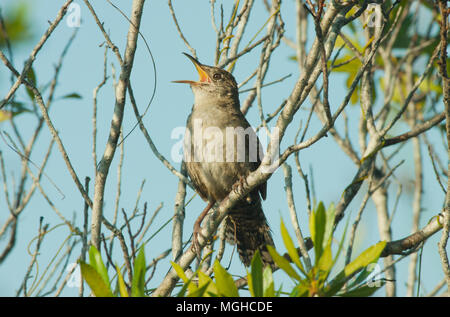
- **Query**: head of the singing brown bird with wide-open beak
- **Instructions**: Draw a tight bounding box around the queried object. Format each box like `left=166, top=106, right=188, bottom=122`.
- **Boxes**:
left=173, top=53, right=238, bottom=99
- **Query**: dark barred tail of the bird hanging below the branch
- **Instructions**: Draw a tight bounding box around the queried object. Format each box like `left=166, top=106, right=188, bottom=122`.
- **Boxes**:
left=225, top=195, right=274, bottom=267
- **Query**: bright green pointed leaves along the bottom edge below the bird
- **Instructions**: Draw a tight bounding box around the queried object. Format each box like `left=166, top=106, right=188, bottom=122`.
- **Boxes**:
left=172, top=203, right=386, bottom=297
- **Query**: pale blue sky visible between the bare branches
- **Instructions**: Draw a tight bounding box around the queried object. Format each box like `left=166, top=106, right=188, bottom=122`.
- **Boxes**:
left=0, top=0, right=443, bottom=296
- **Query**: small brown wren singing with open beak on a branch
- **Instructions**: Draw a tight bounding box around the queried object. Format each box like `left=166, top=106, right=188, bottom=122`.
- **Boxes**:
left=174, top=53, right=274, bottom=266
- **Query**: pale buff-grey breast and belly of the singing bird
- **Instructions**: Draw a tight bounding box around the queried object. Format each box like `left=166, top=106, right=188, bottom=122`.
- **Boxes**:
left=184, top=109, right=261, bottom=201
